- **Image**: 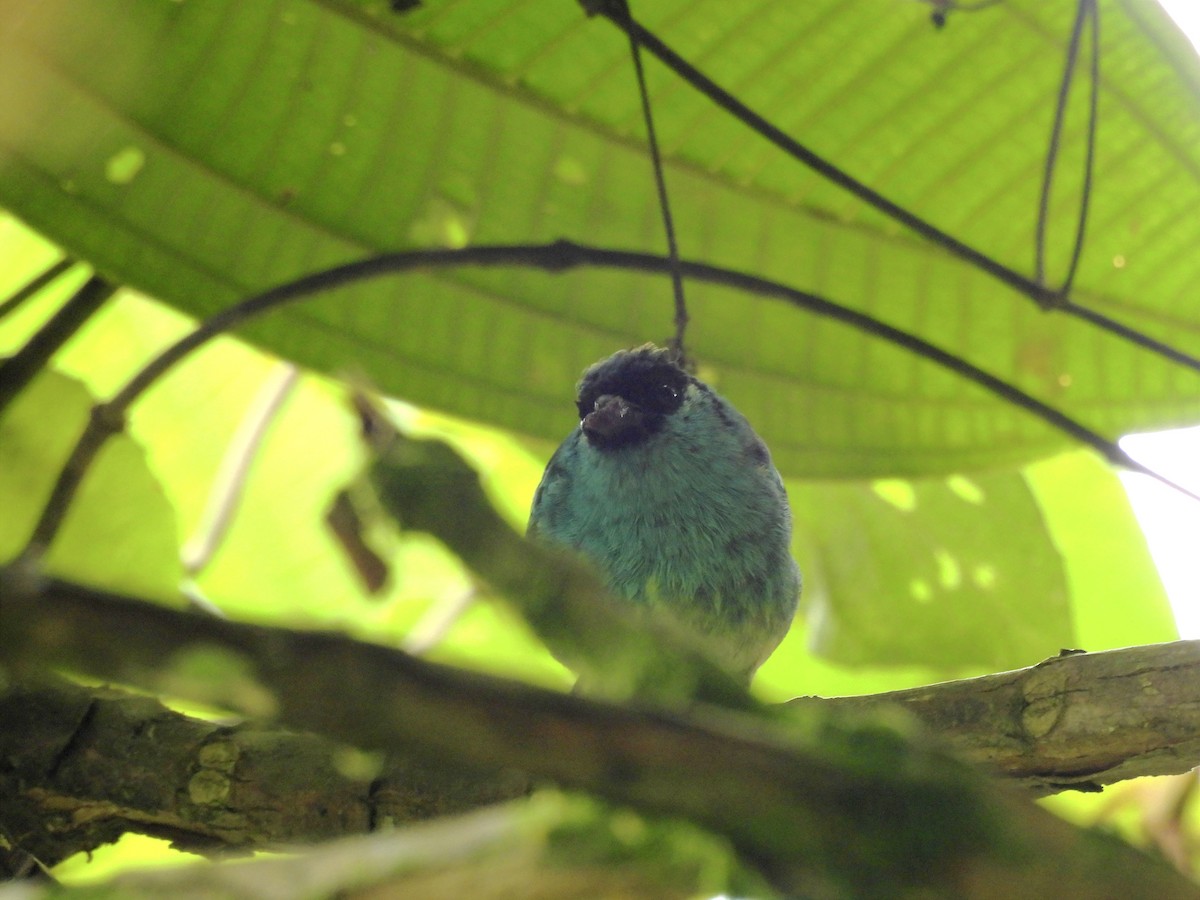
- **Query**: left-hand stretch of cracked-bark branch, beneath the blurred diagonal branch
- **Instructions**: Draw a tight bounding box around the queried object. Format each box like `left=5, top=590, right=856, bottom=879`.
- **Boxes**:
left=0, top=678, right=528, bottom=866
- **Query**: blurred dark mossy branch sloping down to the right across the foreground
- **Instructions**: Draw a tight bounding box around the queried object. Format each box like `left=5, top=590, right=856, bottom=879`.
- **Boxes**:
left=0, top=577, right=1198, bottom=898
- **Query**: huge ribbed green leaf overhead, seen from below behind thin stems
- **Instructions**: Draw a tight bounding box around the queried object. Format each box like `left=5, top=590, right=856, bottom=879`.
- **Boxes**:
left=0, top=0, right=1200, bottom=476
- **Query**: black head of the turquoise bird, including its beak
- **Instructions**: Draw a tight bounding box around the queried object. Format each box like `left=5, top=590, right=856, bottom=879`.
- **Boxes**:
left=576, top=344, right=691, bottom=449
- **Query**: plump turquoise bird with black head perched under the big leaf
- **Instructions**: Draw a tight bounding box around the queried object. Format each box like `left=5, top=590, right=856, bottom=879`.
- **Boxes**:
left=527, top=344, right=800, bottom=684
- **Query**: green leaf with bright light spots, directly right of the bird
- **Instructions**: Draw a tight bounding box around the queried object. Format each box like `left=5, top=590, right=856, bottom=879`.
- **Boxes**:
left=791, top=473, right=1074, bottom=671
